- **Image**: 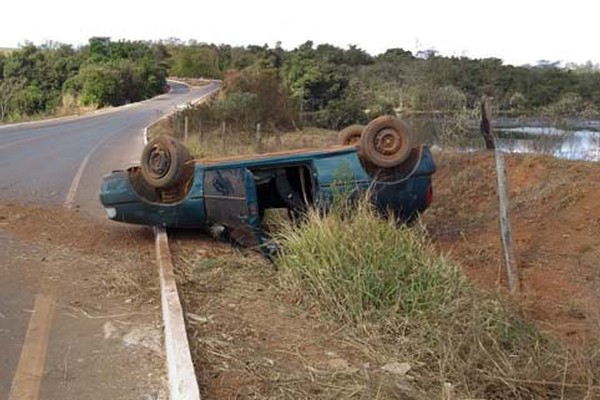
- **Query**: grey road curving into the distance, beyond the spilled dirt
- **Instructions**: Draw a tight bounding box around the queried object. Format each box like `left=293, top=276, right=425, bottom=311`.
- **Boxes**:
left=0, top=81, right=219, bottom=212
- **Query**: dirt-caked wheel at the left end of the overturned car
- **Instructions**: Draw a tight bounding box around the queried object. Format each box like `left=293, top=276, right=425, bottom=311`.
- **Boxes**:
left=141, top=136, right=191, bottom=188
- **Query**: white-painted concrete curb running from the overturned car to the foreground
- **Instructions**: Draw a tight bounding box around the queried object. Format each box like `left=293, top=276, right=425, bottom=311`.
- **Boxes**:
left=154, top=227, right=200, bottom=400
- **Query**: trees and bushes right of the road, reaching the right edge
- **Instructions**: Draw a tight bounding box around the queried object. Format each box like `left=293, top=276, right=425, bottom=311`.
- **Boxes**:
left=163, top=41, right=600, bottom=128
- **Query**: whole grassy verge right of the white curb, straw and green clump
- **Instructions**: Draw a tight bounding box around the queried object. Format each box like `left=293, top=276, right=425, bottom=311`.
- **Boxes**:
left=175, top=188, right=600, bottom=399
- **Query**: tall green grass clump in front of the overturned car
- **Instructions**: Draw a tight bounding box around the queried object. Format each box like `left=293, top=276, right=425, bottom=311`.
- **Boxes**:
left=279, top=198, right=470, bottom=323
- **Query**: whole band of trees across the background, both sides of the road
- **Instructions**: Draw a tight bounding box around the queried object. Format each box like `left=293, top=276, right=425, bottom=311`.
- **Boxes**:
left=0, top=38, right=600, bottom=128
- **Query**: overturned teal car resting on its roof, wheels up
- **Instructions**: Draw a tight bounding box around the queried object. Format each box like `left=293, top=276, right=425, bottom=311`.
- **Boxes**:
left=100, top=116, right=435, bottom=246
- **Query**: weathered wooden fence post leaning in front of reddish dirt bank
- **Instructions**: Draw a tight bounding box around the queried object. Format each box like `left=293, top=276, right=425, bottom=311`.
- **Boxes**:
left=481, top=98, right=519, bottom=294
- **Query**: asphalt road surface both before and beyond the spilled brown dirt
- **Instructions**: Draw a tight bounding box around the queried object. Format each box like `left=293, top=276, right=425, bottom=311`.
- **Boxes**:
left=0, top=82, right=219, bottom=400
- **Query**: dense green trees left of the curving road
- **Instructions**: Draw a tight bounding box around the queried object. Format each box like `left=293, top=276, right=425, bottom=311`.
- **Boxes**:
left=0, top=37, right=167, bottom=120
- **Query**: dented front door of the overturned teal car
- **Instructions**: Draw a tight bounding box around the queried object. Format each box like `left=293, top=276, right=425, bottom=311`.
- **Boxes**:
left=204, top=168, right=261, bottom=247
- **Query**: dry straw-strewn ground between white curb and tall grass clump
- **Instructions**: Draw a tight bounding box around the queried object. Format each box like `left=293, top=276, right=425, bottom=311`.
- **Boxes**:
left=174, top=241, right=414, bottom=399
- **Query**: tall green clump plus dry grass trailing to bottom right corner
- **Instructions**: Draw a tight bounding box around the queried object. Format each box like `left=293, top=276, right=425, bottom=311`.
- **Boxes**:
left=275, top=201, right=600, bottom=399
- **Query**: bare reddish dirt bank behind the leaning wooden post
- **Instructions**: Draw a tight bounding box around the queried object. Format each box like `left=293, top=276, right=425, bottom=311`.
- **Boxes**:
left=423, top=153, right=600, bottom=342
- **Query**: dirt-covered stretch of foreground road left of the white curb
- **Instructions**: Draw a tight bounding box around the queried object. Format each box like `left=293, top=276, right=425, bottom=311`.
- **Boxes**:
left=0, top=204, right=167, bottom=400
